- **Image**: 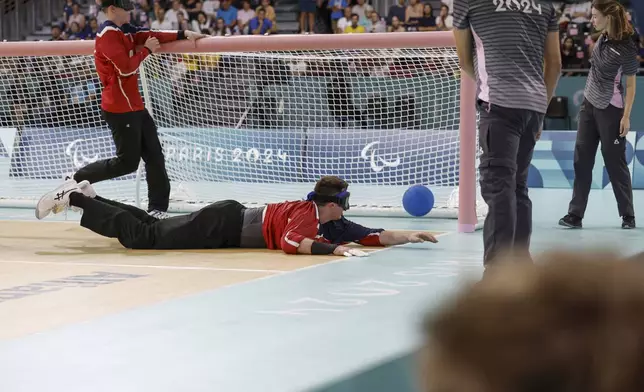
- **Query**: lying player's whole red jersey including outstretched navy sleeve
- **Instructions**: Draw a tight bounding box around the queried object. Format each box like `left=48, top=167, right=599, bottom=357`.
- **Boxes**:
left=262, top=201, right=384, bottom=254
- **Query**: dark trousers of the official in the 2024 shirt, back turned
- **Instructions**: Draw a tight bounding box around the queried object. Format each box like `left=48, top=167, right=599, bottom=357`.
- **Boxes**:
left=479, top=102, right=543, bottom=265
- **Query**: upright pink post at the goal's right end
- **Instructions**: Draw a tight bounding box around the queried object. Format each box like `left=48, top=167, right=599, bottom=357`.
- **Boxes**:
left=458, top=72, right=478, bottom=233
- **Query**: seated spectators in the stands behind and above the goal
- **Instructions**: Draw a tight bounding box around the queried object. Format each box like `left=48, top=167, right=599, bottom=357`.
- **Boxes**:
left=46, top=0, right=644, bottom=72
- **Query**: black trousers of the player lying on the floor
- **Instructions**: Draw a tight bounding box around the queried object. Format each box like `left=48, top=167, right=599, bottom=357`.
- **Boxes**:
left=70, top=193, right=245, bottom=249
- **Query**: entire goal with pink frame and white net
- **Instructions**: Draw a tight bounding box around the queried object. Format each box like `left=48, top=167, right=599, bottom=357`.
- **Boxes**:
left=0, top=32, right=484, bottom=232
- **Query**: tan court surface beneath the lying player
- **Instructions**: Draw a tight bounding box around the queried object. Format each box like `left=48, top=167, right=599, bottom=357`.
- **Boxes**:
left=0, top=221, right=416, bottom=340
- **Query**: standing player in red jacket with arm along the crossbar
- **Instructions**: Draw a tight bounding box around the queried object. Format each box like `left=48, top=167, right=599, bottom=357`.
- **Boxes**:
left=68, top=0, right=204, bottom=218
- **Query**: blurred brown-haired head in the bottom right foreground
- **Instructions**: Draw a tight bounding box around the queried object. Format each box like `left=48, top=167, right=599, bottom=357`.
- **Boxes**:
left=421, top=253, right=644, bottom=392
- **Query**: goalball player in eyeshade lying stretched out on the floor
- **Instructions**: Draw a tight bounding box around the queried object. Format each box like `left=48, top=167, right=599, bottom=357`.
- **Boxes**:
left=36, top=176, right=437, bottom=256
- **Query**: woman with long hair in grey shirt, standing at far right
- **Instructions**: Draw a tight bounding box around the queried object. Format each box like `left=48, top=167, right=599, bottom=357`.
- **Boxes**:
left=559, top=0, right=639, bottom=229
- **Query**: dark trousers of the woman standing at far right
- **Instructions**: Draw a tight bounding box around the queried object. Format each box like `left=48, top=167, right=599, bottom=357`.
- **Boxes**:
left=568, top=100, right=635, bottom=218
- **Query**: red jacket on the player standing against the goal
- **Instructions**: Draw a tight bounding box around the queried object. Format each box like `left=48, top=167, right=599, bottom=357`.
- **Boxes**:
left=94, top=21, right=184, bottom=113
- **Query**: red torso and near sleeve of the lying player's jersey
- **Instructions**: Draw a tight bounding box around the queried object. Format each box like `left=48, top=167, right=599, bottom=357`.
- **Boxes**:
left=262, top=201, right=320, bottom=254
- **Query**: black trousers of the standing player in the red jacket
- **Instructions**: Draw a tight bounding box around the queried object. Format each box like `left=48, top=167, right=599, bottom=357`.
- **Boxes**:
left=74, top=110, right=170, bottom=211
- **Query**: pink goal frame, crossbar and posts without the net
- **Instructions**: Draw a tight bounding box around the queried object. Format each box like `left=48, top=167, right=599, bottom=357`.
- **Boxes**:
left=0, top=31, right=478, bottom=232
